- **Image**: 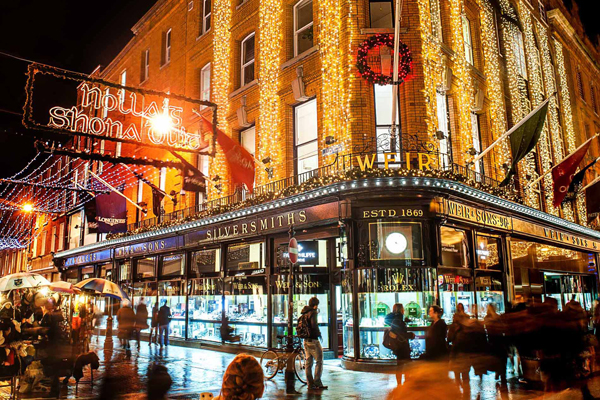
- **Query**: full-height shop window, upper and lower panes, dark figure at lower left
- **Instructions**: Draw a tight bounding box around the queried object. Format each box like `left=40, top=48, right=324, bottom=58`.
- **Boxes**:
left=221, top=242, right=268, bottom=347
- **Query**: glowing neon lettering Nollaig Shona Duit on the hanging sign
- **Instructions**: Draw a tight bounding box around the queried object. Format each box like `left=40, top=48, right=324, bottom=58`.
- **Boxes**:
left=48, top=83, right=205, bottom=149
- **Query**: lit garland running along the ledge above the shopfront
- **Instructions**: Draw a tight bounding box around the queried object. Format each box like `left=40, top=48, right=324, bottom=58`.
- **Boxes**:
left=107, top=168, right=522, bottom=239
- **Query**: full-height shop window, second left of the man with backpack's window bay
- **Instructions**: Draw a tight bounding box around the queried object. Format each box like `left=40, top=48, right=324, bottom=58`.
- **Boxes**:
left=188, top=249, right=223, bottom=342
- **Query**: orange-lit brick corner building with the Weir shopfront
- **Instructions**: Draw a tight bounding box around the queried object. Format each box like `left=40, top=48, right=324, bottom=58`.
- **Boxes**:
left=49, top=0, right=600, bottom=369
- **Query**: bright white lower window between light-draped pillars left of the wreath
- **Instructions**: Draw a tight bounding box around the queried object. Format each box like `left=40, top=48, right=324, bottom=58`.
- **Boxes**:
left=294, top=99, right=319, bottom=175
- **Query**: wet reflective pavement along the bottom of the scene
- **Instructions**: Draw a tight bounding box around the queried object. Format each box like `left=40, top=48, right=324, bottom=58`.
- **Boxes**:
left=0, top=338, right=600, bottom=400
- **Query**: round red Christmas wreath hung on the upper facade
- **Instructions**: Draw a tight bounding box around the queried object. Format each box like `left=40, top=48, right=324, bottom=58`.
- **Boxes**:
left=356, top=33, right=412, bottom=85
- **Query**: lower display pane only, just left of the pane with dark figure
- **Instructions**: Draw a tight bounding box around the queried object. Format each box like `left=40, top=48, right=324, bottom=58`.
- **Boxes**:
left=188, top=279, right=223, bottom=342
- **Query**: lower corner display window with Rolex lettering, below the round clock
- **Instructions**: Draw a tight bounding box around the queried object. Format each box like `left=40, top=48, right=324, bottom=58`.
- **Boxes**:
left=356, top=268, right=436, bottom=359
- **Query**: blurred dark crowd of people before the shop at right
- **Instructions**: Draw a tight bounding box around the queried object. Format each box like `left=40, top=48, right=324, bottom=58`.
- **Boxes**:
left=385, top=297, right=600, bottom=398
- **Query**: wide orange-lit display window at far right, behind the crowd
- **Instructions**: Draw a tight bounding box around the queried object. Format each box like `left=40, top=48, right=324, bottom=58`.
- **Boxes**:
left=510, top=237, right=598, bottom=311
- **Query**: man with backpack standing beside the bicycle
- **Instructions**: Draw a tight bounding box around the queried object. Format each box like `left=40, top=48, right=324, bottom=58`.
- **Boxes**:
left=296, top=297, right=327, bottom=390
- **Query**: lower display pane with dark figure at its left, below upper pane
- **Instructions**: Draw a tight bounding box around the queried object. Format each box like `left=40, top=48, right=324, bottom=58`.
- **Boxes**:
left=223, top=276, right=267, bottom=347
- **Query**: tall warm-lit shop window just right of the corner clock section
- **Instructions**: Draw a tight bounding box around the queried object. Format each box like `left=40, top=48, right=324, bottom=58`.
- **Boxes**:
left=437, top=226, right=476, bottom=324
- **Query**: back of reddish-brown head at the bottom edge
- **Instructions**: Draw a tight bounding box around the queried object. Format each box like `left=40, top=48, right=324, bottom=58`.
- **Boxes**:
left=215, top=354, right=265, bottom=400
